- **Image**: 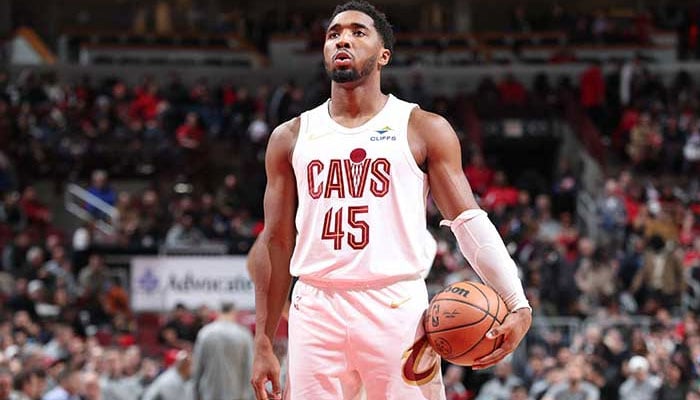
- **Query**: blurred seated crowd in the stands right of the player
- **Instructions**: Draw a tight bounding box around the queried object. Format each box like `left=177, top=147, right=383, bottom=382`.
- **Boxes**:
left=422, top=59, right=700, bottom=399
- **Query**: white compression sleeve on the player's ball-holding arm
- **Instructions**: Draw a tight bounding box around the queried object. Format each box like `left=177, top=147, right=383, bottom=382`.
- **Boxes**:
left=440, top=209, right=532, bottom=311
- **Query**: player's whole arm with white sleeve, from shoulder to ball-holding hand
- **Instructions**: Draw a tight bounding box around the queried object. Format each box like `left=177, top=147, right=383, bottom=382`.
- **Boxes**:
left=408, top=109, right=532, bottom=369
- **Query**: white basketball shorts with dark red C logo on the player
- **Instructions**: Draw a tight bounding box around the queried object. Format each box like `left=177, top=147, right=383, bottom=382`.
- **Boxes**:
left=285, top=279, right=445, bottom=400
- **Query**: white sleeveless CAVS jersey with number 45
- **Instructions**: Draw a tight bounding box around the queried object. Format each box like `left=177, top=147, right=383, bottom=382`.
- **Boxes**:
left=290, top=96, right=435, bottom=287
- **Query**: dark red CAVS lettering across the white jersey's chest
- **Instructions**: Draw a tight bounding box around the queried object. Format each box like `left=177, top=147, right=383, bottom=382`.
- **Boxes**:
left=306, top=148, right=391, bottom=199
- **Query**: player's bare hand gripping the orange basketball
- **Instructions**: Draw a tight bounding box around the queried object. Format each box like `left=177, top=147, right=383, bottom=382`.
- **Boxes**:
left=472, top=308, right=532, bottom=369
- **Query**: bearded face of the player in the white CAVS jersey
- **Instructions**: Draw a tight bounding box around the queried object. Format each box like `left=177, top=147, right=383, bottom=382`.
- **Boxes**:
left=323, top=11, right=390, bottom=83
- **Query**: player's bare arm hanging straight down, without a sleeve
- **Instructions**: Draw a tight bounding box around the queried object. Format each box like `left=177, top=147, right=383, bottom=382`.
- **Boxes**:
left=248, top=118, right=299, bottom=399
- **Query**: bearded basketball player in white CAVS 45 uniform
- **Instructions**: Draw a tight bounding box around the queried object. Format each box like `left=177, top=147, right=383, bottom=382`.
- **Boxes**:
left=251, top=1, right=532, bottom=400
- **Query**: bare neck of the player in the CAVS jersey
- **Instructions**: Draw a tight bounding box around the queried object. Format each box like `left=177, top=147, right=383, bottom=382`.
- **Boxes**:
left=329, top=73, right=387, bottom=118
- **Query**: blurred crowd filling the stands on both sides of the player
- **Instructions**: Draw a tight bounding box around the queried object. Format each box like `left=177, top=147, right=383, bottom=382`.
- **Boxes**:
left=0, top=59, right=700, bottom=400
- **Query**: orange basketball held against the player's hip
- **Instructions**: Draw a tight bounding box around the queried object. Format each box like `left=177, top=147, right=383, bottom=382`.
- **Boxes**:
left=424, top=281, right=508, bottom=366
